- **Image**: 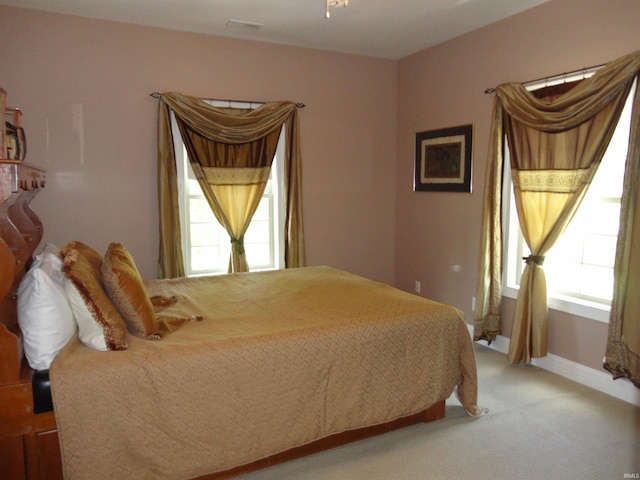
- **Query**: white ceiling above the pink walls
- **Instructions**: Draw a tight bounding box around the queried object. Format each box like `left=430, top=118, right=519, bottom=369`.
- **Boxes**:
left=0, top=0, right=549, bottom=59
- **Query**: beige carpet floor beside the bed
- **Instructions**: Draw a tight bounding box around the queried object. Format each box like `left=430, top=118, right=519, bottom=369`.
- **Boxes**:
left=238, top=345, right=640, bottom=480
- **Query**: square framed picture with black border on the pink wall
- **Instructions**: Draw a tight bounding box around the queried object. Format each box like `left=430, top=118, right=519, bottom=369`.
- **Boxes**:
left=413, top=125, right=473, bottom=192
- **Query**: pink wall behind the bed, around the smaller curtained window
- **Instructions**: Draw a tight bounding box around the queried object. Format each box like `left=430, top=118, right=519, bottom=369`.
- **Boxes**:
left=0, top=7, right=397, bottom=283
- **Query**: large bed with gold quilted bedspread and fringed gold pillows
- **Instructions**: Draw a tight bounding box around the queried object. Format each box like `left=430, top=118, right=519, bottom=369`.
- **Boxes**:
left=0, top=160, right=482, bottom=479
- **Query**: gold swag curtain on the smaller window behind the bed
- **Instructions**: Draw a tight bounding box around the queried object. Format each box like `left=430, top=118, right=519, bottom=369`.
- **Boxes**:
left=158, top=92, right=305, bottom=278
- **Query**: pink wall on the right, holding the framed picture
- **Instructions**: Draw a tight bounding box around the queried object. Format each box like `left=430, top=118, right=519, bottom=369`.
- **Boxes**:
left=396, top=0, right=640, bottom=368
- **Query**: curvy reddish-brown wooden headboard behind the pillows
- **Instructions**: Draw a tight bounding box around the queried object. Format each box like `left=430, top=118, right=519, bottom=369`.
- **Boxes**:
left=0, top=160, right=45, bottom=386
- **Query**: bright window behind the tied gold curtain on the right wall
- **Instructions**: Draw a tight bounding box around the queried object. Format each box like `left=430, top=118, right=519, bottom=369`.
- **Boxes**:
left=503, top=80, right=633, bottom=322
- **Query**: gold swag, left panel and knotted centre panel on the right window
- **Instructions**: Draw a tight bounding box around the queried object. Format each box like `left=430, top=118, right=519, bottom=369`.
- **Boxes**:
left=474, top=53, right=640, bottom=368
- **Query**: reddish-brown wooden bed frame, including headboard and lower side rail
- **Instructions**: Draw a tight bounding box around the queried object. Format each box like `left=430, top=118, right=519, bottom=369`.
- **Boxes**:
left=0, top=160, right=445, bottom=480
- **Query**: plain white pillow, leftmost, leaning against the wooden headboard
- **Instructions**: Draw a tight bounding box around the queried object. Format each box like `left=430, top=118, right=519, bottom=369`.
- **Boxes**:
left=17, top=246, right=76, bottom=370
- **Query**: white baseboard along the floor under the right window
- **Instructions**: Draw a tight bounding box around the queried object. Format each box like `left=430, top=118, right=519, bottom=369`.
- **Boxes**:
left=469, top=325, right=640, bottom=407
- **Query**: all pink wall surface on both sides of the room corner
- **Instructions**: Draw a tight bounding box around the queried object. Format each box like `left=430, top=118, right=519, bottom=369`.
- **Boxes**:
left=0, top=0, right=640, bottom=368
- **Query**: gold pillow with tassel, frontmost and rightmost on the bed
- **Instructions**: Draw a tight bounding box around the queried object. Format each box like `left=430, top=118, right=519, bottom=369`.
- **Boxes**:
left=101, top=243, right=184, bottom=340
